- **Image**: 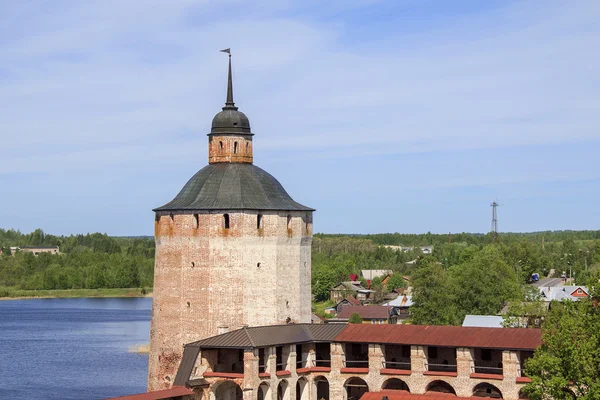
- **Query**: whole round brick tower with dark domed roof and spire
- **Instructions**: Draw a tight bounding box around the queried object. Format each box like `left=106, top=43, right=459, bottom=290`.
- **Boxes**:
left=148, top=56, right=314, bottom=390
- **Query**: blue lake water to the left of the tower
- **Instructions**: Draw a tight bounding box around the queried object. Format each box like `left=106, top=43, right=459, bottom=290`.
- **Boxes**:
left=0, top=298, right=152, bottom=400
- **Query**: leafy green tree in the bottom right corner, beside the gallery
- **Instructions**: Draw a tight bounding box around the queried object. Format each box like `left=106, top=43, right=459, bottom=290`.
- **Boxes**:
left=524, top=298, right=600, bottom=400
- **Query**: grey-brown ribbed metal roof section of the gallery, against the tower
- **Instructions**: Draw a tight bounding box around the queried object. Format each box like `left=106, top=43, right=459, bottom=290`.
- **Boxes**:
left=186, top=324, right=343, bottom=349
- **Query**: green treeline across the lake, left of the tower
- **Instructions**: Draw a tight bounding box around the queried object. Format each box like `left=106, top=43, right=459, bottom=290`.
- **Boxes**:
left=0, top=229, right=154, bottom=290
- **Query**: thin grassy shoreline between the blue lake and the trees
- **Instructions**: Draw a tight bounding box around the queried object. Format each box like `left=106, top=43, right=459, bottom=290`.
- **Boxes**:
left=0, top=288, right=152, bottom=301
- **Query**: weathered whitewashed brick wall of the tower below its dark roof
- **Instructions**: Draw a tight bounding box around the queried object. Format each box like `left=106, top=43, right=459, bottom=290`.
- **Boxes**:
left=148, top=210, right=312, bottom=390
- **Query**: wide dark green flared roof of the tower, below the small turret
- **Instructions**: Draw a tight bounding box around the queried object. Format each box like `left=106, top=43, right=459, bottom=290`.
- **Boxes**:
left=154, top=163, right=314, bottom=211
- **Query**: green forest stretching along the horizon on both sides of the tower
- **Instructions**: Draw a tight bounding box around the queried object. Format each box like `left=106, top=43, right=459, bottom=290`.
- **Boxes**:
left=0, top=229, right=600, bottom=316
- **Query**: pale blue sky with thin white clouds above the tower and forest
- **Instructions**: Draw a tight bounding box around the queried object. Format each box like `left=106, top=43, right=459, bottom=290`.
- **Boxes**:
left=0, top=0, right=600, bottom=235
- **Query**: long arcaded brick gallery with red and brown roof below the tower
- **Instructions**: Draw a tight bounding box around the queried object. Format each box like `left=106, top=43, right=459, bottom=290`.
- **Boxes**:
left=130, top=322, right=542, bottom=400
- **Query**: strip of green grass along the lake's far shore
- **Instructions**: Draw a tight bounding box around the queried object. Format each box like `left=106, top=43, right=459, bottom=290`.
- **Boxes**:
left=0, top=287, right=152, bottom=299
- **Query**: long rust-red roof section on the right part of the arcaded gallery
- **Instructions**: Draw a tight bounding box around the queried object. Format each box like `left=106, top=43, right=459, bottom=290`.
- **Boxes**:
left=334, top=324, right=542, bottom=350
